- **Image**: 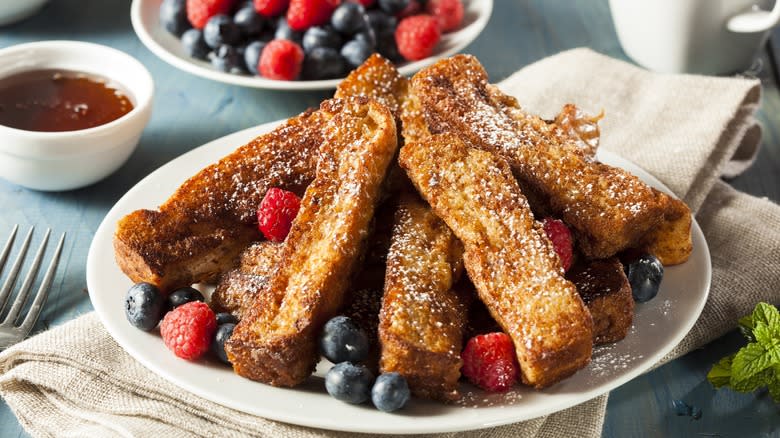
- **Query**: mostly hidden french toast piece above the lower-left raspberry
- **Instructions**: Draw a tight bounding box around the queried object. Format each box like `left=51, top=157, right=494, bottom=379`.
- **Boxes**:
left=210, top=241, right=282, bottom=320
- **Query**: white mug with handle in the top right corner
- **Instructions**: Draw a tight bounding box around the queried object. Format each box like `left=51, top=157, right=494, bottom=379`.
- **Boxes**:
left=609, top=0, right=780, bottom=74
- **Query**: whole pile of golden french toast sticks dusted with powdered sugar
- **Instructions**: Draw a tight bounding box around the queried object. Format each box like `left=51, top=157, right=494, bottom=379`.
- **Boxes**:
left=114, top=55, right=692, bottom=401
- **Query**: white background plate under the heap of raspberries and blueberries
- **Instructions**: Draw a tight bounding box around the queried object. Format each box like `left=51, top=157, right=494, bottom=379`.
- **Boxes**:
left=130, top=0, right=493, bottom=90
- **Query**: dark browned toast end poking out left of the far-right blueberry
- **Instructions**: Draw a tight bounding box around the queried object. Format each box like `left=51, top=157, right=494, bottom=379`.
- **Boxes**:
left=566, top=257, right=634, bottom=345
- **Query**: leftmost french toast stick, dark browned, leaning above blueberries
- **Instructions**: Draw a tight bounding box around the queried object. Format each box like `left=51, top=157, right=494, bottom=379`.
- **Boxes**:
left=114, top=111, right=330, bottom=291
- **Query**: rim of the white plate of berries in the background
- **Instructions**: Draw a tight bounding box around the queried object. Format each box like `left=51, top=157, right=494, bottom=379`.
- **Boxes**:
left=130, top=0, right=493, bottom=91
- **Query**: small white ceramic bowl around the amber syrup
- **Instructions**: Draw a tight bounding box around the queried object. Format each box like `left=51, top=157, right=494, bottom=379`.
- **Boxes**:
left=0, top=41, right=154, bottom=191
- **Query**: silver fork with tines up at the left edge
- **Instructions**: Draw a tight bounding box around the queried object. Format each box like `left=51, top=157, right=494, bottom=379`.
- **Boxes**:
left=0, top=225, right=65, bottom=350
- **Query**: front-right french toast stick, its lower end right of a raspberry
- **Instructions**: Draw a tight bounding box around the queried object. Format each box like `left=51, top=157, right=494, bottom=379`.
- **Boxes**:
left=399, top=134, right=593, bottom=388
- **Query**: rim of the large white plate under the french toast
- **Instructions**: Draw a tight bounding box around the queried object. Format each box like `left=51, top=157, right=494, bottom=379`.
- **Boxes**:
left=87, top=120, right=712, bottom=435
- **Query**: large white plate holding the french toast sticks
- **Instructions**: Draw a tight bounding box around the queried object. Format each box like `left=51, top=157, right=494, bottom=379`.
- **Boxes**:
left=87, top=122, right=710, bottom=434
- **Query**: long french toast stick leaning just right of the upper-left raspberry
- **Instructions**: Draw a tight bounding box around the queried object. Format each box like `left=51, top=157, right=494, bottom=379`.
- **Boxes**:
left=225, top=98, right=398, bottom=386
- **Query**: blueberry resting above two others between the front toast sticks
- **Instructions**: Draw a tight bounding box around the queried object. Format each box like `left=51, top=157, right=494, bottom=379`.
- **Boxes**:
left=320, top=316, right=368, bottom=363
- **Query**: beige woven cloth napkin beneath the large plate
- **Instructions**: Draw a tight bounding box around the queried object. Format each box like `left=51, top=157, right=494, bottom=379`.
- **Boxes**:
left=0, top=49, right=780, bottom=438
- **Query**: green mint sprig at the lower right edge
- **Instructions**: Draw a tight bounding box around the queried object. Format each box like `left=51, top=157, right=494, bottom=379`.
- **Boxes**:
left=707, top=303, right=780, bottom=403
